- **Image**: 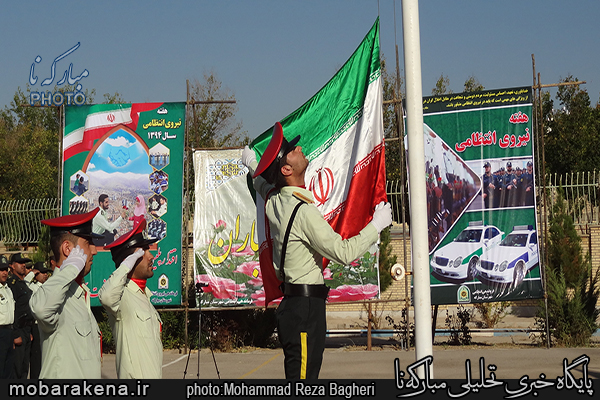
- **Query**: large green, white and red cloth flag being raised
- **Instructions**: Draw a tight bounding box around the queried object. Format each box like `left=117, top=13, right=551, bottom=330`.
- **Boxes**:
left=251, top=18, right=387, bottom=304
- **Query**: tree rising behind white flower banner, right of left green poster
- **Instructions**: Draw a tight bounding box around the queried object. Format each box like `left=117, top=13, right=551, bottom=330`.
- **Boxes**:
left=186, top=72, right=250, bottom=148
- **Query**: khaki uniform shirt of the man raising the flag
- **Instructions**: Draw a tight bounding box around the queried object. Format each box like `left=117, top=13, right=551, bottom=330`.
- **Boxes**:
left=250, top=162, right=378, bottom=285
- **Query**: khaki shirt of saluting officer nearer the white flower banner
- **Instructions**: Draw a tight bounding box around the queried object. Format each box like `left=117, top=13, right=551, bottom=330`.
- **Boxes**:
left=98, top=265, right=163, bottom=379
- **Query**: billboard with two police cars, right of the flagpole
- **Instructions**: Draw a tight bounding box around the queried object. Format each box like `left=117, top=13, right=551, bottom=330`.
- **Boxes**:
left=405, top=87, right=543, bottom=304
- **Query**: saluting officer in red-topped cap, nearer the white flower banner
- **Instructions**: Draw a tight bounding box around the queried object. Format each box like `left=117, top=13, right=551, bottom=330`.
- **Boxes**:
left=98, top=219, right=163, bottom=379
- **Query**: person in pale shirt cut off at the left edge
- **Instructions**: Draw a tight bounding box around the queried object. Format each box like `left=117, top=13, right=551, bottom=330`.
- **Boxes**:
left=0, top=256, right=15, bottom=379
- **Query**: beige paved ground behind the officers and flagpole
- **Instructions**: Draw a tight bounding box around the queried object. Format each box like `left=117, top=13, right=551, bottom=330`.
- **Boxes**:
left=102, top=339, right=600, bottom=379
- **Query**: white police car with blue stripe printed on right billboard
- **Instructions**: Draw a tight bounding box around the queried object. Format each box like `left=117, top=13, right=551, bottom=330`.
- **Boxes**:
left=477, top=225, right=539, bottom=287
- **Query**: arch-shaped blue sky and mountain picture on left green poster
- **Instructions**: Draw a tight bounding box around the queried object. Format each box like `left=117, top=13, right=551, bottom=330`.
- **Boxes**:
left=82, top=125, right=154, bottom=247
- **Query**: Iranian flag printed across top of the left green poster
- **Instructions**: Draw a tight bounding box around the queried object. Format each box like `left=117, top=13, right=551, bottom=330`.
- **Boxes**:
left=63, top=103, right=163, bottom=161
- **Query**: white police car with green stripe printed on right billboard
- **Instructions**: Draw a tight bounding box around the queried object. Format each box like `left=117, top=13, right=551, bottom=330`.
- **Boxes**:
left=430, top=221, right=504, bottom=283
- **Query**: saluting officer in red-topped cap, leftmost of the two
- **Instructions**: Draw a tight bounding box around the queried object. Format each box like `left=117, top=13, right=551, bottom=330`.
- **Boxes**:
left=29, top=208, right=101, bottom=379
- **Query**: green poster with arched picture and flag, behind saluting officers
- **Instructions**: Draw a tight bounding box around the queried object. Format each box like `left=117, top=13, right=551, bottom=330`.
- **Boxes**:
left=62, top=103, right=185, bottom=306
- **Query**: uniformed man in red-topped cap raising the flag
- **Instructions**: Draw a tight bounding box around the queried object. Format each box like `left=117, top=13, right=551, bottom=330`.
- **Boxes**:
left=242, top=123, right=392, bottom=379
